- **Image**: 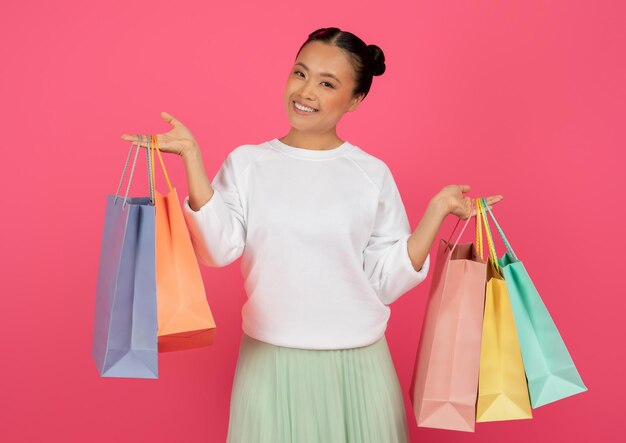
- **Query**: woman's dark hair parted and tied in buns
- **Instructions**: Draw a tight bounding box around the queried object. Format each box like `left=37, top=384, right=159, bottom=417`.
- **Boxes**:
left=296, top=28, right=385, bottom=98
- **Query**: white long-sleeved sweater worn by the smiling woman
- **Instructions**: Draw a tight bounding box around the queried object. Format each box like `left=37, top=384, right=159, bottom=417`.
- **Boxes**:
left=183, top=138, right=430, bottom=349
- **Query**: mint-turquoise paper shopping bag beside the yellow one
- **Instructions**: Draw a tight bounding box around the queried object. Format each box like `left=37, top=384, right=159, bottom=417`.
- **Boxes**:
left=478, top=199, right=587, bottom=408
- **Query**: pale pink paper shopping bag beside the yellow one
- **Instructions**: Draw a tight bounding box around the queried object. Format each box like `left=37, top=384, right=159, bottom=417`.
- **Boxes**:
left=409, top=205, right=486, bottom=432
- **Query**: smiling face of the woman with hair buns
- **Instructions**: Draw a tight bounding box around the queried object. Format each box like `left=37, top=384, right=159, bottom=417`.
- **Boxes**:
left=285, top=41, right=363, bottom=133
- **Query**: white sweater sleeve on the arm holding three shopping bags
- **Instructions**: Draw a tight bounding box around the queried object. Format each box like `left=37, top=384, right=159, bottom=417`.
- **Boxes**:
left=363, top=168, right=430, bottom=305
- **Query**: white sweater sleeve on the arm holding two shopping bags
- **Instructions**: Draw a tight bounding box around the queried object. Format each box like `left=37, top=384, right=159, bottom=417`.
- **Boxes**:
left=183, top=154, right=246, bottom=267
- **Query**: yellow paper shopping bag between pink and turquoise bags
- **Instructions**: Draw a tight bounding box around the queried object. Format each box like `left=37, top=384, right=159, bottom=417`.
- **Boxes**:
left=476, top=199, right=532, bottom=422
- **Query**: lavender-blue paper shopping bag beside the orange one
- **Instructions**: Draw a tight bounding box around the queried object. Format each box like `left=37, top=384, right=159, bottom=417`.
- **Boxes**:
left=91, top=140, right=158, bottom=378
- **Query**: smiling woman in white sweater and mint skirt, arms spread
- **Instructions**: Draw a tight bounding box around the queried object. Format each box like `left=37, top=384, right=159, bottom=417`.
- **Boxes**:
left=122, top=28, right=502, bottom=443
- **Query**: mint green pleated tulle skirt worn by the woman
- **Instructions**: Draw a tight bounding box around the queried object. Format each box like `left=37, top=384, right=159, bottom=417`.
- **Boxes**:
left=227, top=333, right=409, bottom=443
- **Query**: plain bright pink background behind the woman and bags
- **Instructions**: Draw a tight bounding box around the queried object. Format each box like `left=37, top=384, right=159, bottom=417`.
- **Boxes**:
left=0, top=0, right=626, bottom=442
